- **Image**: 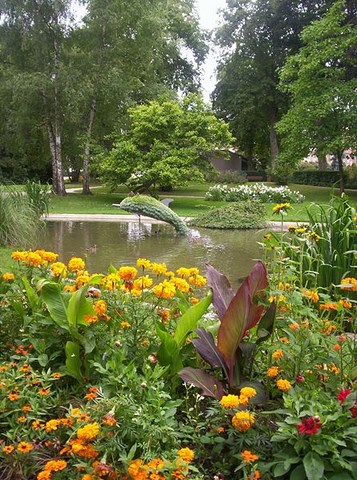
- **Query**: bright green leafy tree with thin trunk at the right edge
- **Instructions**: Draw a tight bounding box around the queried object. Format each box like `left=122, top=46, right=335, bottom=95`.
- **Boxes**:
left=278, top=0, right=357, bottom=192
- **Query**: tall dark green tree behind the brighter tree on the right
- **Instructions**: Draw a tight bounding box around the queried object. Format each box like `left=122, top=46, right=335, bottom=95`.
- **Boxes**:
left=213, top=0, right=331, bottom=170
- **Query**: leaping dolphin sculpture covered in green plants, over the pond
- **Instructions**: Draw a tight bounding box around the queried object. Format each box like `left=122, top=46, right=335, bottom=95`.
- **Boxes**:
left=119, top=195, right=188, bottom=235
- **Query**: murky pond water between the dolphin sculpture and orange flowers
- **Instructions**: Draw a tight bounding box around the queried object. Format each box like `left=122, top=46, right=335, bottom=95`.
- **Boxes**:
left=39, top=221, right=264, bottom=285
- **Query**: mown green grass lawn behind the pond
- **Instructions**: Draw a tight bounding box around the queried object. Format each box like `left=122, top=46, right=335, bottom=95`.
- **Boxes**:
left=50, top=183, right=357, bottom=222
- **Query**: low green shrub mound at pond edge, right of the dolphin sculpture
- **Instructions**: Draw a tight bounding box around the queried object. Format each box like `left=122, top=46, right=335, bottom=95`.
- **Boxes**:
left=190, top=200, right=266, bottom=229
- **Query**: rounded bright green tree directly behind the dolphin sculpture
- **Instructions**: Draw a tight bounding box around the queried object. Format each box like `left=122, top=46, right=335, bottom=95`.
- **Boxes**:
left=102, top=94, right=233, bottom=191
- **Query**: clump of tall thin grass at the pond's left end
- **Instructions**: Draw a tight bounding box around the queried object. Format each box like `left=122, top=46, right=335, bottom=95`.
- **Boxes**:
left=0, top=186, right=41, bottom=248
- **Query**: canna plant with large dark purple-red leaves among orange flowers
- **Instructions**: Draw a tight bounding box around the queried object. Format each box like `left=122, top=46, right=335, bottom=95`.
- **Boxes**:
left=179, top=261, right=276, bottom=399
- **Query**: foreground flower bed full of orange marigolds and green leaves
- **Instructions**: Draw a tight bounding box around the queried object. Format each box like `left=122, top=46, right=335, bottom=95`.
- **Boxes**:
left=0, top=230, right=357, bottom=480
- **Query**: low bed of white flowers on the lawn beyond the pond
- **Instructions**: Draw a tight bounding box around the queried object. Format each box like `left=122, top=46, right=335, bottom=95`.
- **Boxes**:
left=206, top=183, right=305, bottom=203
